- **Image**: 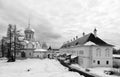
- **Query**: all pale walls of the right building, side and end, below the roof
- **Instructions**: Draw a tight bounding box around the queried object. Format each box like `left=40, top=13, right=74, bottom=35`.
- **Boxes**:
left=60, top=46, right=113, bottom=67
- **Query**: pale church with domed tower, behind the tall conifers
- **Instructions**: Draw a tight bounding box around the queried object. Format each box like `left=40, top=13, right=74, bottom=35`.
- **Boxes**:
left=17, top=25, right=48, bottom=58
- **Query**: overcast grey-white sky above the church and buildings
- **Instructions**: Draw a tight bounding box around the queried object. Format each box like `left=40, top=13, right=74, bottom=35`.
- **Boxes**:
left=0, top=0, right=120, bottom=48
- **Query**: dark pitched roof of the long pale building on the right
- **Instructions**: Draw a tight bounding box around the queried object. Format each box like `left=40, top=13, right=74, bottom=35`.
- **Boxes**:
left=61, top=33, right=113, bottom=48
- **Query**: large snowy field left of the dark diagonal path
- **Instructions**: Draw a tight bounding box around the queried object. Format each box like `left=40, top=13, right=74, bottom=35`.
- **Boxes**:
left=0, top=59, right=84, bottom=77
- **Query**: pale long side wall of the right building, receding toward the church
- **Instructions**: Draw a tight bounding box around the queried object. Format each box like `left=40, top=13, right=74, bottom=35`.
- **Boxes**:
left=60, top=46, right=91, bottom=68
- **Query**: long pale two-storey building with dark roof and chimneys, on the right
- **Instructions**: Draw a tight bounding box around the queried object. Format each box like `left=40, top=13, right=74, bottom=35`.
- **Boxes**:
left=60, top=29, right=113, bottom=68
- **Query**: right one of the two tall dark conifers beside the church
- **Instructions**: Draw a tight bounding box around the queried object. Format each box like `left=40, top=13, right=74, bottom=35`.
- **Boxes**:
left=8, top=25, right=22, bottom=62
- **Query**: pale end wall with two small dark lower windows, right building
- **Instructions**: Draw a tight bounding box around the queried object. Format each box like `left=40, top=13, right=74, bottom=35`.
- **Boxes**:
left=92, top=46, right=113, bottom=67
